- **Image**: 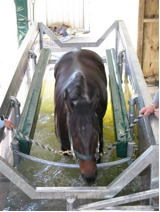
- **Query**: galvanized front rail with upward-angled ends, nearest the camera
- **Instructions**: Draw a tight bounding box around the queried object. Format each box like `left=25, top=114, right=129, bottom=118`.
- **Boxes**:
left=0, top=146, right=159, bottom=209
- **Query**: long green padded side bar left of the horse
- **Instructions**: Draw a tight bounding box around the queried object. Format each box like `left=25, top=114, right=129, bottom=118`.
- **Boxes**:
left=15, top=49, right=51, bottom=154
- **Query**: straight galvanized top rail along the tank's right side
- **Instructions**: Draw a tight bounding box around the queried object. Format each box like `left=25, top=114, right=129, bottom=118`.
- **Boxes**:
left=117, top=21, right=159, bottom=147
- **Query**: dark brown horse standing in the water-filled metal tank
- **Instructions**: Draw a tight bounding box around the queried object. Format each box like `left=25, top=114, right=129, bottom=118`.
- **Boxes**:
left=54, top=49, right=107, bottom=183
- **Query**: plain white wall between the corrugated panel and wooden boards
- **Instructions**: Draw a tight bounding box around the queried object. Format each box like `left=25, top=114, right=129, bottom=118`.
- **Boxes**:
left=90, top=0, right=139, bottom=50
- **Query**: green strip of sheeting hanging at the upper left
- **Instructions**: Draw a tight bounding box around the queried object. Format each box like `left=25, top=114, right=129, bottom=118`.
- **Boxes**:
left=14, top=0, right=28, bottom=46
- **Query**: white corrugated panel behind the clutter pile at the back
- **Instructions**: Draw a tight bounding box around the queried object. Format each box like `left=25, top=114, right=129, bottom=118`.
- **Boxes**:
left=29, top=0, right=84, bottom=29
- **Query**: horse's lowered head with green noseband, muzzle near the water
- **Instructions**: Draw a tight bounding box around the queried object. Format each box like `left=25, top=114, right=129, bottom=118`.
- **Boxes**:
left=65, top=89, right=100, bottom=182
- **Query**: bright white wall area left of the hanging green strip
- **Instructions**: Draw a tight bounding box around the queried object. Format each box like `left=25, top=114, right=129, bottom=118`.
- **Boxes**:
left=0, top=0, right=18, bottom=105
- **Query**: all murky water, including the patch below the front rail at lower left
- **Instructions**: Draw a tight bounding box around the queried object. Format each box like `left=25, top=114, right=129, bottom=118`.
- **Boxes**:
left=5, top=66, right=149, bottom=211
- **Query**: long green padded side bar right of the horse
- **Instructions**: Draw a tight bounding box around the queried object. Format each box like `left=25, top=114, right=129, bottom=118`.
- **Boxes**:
left=106, top=49, right=132, bottom=157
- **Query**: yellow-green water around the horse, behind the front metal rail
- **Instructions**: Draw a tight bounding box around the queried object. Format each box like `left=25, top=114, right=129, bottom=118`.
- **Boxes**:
left=18, top=67, right=125, bottom=187
